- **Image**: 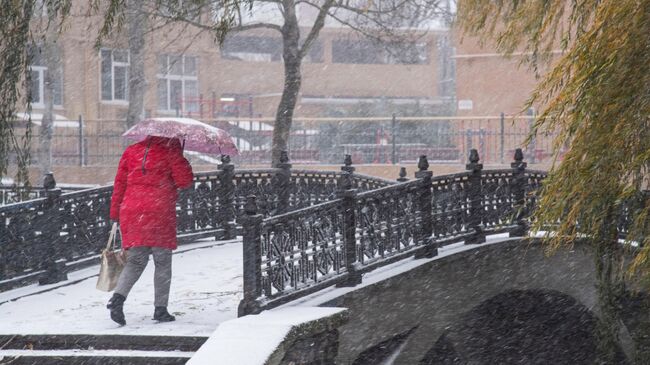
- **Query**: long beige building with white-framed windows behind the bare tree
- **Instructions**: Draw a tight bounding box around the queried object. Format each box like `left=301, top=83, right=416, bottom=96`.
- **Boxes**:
left=26, top=2, right=448, bottom=120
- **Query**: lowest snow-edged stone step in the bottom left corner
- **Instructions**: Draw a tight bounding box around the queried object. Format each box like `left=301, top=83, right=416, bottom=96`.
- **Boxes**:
left=0, top=350, right=194, bottom=365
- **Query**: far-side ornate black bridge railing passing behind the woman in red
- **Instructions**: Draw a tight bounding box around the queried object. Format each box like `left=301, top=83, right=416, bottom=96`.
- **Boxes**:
left=0, top=155, right=392, bottom=291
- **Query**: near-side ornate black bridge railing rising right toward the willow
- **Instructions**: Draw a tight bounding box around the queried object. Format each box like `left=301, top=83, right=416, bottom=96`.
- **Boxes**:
left=234, top=150, right=546, bottom=315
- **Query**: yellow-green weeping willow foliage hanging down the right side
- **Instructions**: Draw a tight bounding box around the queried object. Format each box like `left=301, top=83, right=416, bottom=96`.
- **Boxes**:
left=459, top=0, right=650, bottom=364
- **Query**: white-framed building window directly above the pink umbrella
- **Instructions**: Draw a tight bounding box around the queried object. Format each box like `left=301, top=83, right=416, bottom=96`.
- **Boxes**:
left=158, top=55, right=199, bottom=113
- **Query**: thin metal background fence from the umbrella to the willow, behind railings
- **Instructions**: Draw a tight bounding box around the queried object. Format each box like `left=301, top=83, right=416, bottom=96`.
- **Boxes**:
left=211, top=114, right=561, bottom=164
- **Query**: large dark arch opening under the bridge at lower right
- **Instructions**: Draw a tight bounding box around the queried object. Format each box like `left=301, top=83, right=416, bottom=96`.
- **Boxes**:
left=420, top=289, right=612, bottom=365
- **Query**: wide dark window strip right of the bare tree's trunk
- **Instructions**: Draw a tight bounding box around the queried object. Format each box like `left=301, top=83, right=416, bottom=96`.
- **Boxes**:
left=332, top=39, right=429, bottom=65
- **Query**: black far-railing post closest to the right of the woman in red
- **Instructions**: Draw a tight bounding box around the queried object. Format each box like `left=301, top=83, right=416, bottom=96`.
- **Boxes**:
left=217, top=155, right=237, bottom=240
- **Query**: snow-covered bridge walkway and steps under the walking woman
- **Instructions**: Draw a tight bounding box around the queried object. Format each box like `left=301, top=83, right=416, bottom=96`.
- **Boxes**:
left=0, top=240, right=242, bottom=364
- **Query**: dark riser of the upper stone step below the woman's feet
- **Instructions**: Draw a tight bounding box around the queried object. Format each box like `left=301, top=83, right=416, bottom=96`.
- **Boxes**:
left=0, top=334, right=207, bottom=352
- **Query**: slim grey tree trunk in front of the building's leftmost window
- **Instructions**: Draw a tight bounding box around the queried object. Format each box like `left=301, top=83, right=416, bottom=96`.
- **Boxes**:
left=38, top=29, right=58, bottom=176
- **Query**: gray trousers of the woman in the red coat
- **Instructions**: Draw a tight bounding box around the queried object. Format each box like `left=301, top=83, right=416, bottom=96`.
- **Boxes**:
left=115, top=246, right=172, bottom=307
